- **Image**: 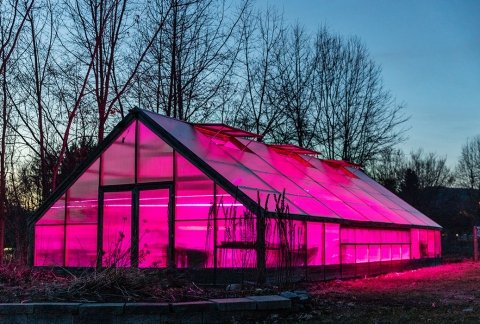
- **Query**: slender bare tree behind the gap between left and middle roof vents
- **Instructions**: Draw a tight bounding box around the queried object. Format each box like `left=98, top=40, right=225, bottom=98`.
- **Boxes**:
left=231, top=8, right=285, bottom=139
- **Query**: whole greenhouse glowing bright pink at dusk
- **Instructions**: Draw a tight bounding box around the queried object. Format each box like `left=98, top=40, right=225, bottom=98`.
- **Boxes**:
left=30, top=109, right=441, bottom=279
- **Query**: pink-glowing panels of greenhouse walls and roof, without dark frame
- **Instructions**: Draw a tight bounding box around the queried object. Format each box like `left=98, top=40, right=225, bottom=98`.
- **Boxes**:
left=34, top=111, right=441, bottom=268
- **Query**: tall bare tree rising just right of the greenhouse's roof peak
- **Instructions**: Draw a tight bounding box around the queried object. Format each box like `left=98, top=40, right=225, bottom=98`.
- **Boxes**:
left=137, top=0, right=248, bottom=120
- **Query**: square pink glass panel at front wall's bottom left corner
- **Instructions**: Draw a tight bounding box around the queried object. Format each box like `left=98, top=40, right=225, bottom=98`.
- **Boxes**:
left=34, top=225, right=65, bottom=266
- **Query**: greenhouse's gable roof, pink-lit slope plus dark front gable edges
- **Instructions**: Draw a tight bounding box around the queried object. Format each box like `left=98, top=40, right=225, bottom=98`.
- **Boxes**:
left=33, top=109, right=441, bottom=229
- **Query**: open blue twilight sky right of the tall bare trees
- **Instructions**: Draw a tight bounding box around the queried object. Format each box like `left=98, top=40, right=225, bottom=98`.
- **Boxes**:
left=260, top=0, right=480, bottom=167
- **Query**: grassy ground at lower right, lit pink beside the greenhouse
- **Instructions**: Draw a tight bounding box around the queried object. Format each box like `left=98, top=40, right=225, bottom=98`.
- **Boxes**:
left=291, top=261, right=480, bottom=323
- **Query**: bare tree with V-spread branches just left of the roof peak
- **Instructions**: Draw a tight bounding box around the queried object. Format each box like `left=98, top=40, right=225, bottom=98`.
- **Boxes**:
left=67, top=0, right=170, bottom=142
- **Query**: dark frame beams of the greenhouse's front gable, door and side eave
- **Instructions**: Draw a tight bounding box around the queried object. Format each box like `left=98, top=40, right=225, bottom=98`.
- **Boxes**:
left=28, top=108, right=440, bottom=269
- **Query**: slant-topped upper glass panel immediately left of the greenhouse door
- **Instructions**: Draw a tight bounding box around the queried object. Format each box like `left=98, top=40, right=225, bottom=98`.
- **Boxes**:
left=67, top=159, right=100, bottom=224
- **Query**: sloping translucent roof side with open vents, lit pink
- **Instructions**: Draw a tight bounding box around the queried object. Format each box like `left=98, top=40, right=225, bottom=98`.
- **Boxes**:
left=144, top=111, right=440, bottom=227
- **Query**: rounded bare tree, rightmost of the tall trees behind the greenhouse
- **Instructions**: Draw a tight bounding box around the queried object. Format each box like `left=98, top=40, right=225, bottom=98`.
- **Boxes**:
left=314, top=28, right=407, bottom=164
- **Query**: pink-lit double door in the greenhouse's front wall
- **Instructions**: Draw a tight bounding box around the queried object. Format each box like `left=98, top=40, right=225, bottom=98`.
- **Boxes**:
left=98, top=186, right=173, bottom=268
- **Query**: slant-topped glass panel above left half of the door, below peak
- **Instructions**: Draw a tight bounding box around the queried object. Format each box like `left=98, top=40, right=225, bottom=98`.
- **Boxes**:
left=102, top=122, right=135, bottom=185
